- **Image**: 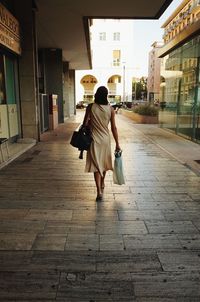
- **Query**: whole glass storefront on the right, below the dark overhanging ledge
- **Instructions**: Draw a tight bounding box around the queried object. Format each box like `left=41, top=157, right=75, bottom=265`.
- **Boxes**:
left=160, top=36, right=200, bottom=141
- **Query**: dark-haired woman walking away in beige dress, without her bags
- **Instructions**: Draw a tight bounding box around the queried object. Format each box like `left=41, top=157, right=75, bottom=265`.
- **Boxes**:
left=83, top=86, right=121, bottom=201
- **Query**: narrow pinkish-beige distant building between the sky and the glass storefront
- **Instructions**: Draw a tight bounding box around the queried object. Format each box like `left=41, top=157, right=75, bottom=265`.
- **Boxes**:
left=147, top=42, right=163, bottom=101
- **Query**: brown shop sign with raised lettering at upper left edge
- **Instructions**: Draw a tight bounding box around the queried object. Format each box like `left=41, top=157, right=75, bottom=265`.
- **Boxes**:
left=0, top=4, right=21, bottom=54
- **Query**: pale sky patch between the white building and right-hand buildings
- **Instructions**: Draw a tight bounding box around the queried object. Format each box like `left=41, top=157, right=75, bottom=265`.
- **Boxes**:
left=133, top=0, right=182, bottom=77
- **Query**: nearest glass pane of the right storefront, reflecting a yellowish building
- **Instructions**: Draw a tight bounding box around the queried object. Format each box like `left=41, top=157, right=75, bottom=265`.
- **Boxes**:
left=177, top=37, right=200, bottom=140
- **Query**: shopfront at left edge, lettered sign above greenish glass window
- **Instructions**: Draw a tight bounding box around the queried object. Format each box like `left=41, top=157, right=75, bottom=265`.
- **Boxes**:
left=0, top=4, right=21, bottom=138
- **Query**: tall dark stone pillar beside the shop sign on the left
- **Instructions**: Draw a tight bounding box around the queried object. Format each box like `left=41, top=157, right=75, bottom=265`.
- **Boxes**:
left=15, top=0, right=40, bottom=140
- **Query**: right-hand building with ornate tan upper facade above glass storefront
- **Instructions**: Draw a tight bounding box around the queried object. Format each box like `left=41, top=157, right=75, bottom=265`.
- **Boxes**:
left=159, top=0, right=200, bottom=143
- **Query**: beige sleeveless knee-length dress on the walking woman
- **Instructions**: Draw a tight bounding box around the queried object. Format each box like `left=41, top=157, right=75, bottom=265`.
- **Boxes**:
left=85, top=103, right=113, bottom=176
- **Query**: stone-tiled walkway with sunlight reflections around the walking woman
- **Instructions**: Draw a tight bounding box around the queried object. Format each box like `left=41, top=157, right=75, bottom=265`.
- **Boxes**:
left=0, top=111, right=200, bottom=302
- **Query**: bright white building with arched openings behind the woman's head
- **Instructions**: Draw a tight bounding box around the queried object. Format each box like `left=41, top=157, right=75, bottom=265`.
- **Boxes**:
left=76, top=19, right=134, bottom=103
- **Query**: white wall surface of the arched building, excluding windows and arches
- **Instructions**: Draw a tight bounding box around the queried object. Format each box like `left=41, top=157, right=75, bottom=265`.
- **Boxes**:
left=76, top=19, right=136, bottom=103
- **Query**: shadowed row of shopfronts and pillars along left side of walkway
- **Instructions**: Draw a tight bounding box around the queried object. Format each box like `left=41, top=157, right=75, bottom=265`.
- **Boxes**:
left=0, top=0, right=75, bottom=153
